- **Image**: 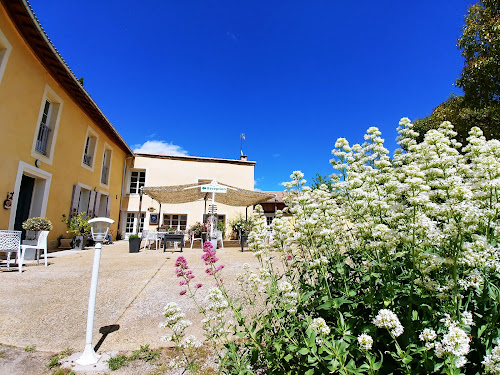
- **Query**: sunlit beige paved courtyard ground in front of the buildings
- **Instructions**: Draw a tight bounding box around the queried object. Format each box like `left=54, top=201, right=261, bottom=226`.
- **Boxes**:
left=0, top=241, right=258, bottom=352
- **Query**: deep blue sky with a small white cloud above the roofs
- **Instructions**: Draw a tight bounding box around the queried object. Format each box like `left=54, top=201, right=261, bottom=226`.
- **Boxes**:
left=30, top=0, right=472, bottom=190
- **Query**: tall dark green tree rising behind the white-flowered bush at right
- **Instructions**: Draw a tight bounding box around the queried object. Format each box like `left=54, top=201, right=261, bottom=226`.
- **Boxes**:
left=415, top=0, right=500, bottom=143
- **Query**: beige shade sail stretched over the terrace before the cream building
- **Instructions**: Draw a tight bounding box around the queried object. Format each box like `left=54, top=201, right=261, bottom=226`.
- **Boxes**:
left=142, top=182, right=274, bottom=207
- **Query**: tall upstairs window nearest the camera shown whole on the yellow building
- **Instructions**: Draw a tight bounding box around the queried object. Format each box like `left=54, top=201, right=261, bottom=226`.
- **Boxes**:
left=31, top=86, right=63, bottom=164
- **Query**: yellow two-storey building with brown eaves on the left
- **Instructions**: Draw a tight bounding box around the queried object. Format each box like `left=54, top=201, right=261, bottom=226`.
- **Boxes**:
left=0, top=0, right=133, bottom=248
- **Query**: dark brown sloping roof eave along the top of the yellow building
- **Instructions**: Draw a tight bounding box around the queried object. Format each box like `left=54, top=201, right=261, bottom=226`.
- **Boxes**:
left=2, top=0, right=133, bottom=155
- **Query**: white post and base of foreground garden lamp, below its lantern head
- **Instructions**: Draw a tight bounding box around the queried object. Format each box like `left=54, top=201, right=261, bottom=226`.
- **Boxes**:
left=76, top=241, right=102, bottom=366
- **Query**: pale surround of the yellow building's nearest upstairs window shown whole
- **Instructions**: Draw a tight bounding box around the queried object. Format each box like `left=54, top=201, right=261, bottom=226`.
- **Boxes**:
left=31, top=85, right=64, bottom=165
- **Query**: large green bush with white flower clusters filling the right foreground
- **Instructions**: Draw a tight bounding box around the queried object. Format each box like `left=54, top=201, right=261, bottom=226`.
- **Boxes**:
left=164, top=118, right=500, bottom=375
